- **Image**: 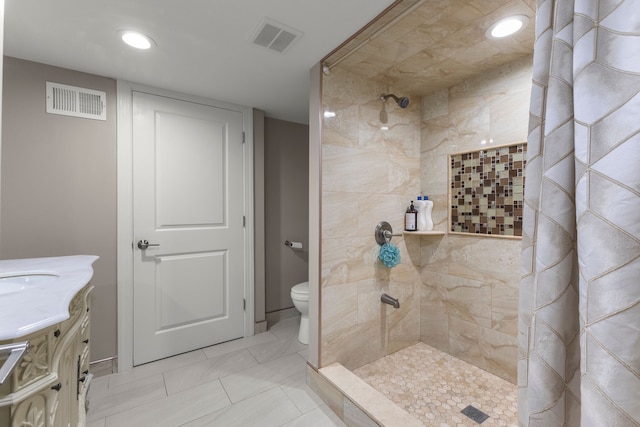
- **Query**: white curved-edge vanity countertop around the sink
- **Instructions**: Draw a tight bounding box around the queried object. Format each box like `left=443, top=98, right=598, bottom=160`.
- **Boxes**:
left=0, top=255, right=98, bottom=340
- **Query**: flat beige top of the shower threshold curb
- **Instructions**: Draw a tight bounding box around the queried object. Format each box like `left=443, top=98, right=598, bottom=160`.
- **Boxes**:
left=318, top=363, right=423, bottom=427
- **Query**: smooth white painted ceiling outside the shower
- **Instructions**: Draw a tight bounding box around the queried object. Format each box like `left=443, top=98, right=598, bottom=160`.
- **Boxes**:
left=4, top=0, right=393, bottom=123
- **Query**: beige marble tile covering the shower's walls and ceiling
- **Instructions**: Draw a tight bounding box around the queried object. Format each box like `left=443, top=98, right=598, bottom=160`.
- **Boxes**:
left=321, top=23, right=531, bottom=378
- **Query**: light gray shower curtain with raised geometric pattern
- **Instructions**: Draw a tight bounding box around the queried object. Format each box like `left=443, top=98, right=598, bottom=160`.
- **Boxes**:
left=518, top=0, right=640, bottom=427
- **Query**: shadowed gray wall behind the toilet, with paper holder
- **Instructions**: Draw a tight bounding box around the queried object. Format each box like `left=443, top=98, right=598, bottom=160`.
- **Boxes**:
left=264, top=118, right=309, bottom=313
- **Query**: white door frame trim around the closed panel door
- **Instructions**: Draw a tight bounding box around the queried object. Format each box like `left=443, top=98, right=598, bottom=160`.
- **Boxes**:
left=117, top=80, right=254, bottom=372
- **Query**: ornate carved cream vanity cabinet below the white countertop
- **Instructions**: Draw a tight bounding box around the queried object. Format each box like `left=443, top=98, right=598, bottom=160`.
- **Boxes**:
left=0, top=284, right=93, bottom=427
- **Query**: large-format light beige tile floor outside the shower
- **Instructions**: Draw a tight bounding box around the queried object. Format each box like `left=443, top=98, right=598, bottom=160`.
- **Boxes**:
left=87, top=317, right=345, bottom=427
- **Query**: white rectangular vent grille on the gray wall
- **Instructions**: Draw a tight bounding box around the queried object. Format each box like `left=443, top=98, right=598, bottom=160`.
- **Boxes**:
left=47, top=82, right=107, bottom=120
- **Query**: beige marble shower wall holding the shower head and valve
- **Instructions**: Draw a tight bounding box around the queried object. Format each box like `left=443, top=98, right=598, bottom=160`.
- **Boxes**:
left=321, top=62, right=421, bottom=367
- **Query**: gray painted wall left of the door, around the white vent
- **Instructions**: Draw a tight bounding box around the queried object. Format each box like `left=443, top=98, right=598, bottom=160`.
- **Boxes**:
left=0, top=57, right=116, bottom=360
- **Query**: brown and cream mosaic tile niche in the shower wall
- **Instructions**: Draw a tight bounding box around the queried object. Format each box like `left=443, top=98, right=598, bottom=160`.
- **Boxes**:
left=449, top=142, right=527, bottom=237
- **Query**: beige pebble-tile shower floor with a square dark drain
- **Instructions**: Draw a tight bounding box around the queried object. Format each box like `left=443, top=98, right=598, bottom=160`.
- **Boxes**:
left=354, top=343, right=518, bottom=427
